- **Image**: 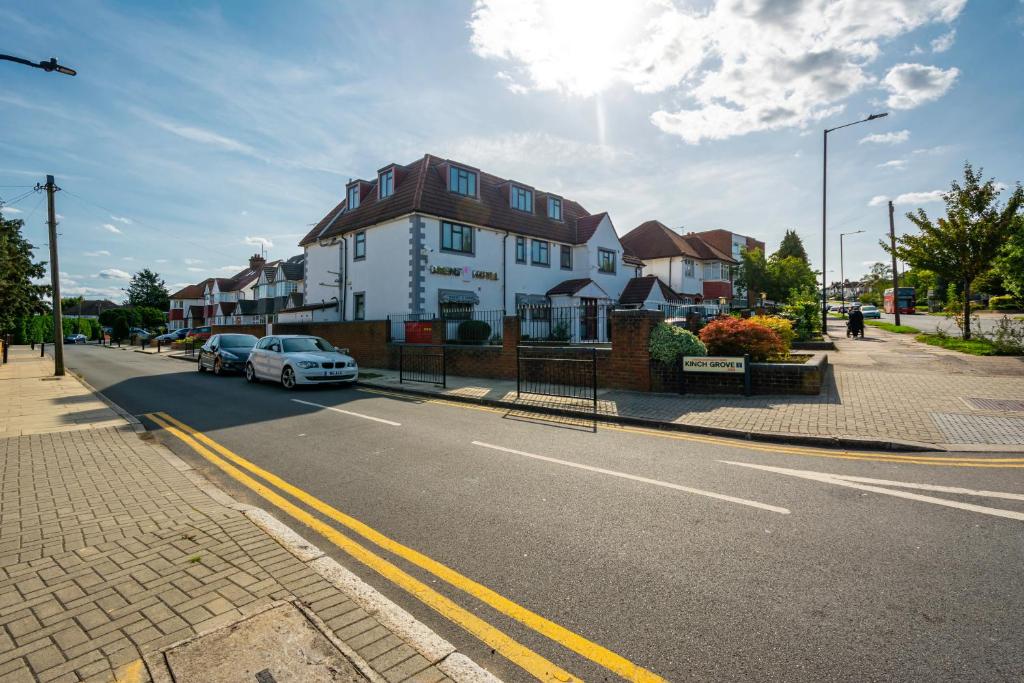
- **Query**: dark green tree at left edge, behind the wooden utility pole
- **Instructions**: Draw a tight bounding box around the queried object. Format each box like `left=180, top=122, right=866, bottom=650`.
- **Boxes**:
left=0, top=210, right=50, bottom=334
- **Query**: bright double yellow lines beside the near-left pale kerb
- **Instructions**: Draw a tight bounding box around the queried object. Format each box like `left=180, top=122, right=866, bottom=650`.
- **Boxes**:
left=146, top=413, right=665, bottom=683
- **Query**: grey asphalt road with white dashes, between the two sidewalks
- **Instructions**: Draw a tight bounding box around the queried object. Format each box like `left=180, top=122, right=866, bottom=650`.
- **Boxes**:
left=67, top=346, right=1024, bottom=681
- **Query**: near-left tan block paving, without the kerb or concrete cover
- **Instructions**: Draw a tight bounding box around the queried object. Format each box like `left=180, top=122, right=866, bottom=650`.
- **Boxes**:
left=0, top=353, right=483, bottom=683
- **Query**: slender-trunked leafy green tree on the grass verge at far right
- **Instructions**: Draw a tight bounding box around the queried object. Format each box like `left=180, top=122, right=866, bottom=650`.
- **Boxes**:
left=880, top=163, right=1024, bottom=339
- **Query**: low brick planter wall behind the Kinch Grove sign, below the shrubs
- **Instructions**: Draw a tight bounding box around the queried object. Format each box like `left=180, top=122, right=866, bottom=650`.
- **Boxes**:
left=651, top=352, right=828, bottom=396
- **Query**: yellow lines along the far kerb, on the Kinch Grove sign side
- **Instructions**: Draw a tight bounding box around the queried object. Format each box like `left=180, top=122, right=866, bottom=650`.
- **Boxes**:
left=358, top=388, right=1024, bottom=468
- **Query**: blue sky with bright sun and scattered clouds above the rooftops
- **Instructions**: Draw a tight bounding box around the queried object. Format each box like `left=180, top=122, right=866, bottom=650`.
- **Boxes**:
left=0, top=0, right=1024, bottom=300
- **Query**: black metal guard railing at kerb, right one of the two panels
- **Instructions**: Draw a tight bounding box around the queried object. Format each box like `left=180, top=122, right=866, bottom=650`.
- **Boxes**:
left=516, top=346, right=597, bottom=416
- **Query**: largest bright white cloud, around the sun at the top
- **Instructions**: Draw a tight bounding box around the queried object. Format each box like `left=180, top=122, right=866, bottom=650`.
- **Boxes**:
left=469, top=0, right=966, bottom=143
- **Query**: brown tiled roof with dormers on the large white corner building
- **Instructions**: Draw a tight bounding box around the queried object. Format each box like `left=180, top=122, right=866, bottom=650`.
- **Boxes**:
left=299, top=155, right=601, bottom=245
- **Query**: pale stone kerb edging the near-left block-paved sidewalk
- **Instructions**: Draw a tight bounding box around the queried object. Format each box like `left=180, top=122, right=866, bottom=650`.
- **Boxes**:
left=68, top=360, right=502, bottom=683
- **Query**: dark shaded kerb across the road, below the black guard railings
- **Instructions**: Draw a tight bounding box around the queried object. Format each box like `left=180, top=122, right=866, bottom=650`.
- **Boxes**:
left=356, top=380, right=948, bottom=453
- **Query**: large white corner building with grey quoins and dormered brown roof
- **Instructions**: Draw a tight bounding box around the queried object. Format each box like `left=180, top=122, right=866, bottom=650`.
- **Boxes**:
left=296, top=155, right=642, bottom=331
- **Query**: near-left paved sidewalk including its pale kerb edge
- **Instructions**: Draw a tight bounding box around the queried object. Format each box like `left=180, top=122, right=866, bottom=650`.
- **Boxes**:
left=0, top=347, right=496, bottom=683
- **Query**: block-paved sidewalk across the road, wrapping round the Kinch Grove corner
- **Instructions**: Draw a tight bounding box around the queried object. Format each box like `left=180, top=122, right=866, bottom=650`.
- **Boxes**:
left=359, top=321, right=1024, bottom=453
